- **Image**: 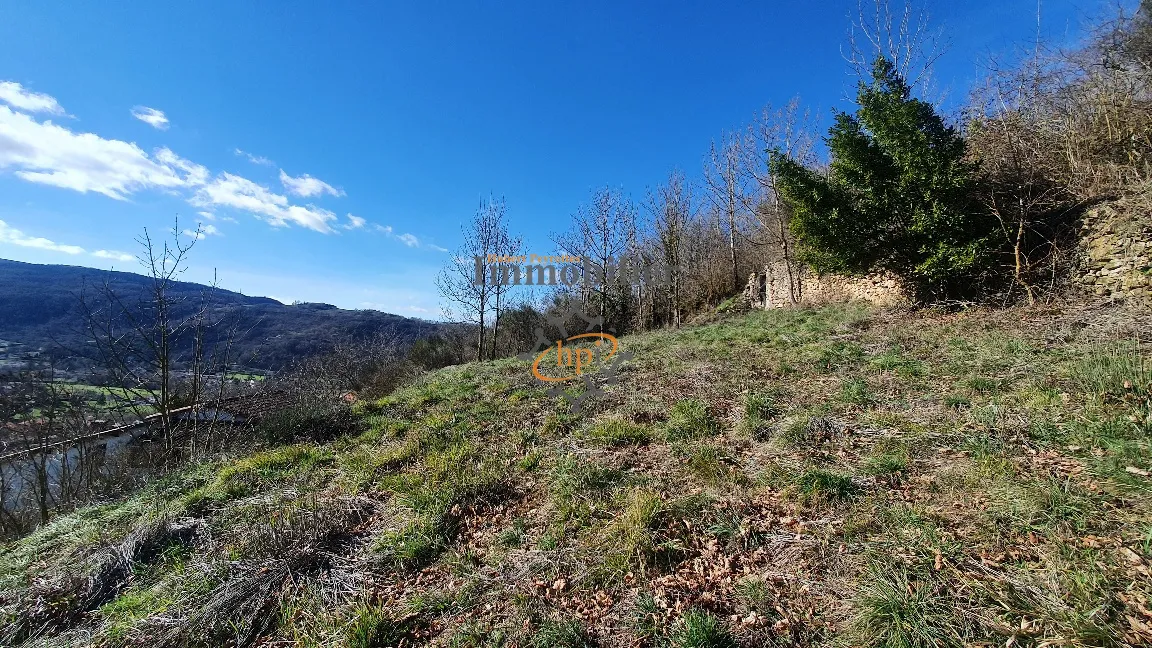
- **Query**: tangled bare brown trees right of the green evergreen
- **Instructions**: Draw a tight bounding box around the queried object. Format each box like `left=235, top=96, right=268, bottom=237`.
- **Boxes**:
left=968, top=2, right=1152, bottom=303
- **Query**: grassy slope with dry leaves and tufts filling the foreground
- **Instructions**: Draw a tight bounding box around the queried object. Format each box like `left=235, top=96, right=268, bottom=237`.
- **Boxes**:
left=0, top=306, right=1152, bottom=647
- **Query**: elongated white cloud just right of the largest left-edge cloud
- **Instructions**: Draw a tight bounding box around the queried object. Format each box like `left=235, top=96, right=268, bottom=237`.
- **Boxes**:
left=192, top=173, right=336, bottom=233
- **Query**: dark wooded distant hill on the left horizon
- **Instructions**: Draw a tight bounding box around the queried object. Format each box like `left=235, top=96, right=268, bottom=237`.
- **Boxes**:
left=0, top=259, right=439, bottom=369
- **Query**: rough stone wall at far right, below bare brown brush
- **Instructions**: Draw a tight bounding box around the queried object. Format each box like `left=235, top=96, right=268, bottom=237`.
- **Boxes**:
left=1073, top=188, right=1152, bottom=306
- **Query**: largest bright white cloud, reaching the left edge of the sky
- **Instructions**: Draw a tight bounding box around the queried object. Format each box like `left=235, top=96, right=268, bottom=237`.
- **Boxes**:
left=0, top=106, right=188, bottom=201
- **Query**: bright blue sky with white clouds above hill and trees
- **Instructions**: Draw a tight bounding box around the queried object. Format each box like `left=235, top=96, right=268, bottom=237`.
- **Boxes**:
left=0, top=0, right=1106, bottom=317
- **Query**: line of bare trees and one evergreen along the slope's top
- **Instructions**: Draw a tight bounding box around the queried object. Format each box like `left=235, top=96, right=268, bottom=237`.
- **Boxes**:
left=425, top=1, right=1152, bottom=360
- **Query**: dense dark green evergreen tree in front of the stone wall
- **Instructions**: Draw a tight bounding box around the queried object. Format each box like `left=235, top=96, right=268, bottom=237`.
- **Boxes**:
left=771, top=58, right=992, bottom=299
